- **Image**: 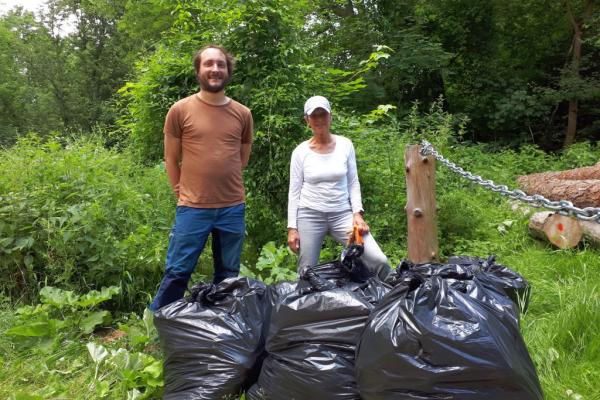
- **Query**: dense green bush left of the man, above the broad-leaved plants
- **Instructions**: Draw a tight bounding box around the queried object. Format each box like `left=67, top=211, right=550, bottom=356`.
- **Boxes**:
left=0, top=137, right=174, bottom=307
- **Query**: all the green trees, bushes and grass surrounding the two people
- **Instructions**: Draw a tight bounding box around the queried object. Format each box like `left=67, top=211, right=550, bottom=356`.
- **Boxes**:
left=0, top=0, right=600, bottom=399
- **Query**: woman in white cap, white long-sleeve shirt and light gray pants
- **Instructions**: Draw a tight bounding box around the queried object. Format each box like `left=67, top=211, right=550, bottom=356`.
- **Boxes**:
left=288, top=96, right=390, bottom=278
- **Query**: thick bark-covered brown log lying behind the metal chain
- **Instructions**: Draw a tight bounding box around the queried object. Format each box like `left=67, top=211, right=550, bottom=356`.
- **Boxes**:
left=517, top=163, right=600, bottom=207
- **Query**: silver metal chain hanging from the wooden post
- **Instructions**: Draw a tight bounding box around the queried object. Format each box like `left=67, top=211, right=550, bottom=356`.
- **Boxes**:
left=421, top=140, right=600, bottom=223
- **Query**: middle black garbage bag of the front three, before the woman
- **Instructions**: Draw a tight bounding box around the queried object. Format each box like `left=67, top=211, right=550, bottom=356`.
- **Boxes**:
left=252, top=262, right=390, bottom=400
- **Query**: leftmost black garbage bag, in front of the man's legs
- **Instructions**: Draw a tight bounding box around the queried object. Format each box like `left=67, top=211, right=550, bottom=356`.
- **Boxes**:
left=154, top=277, right=269, bottom=400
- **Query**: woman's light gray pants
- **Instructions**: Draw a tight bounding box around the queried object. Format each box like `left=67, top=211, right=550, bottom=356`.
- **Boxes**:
left=298, top=208, right=390, bottom=279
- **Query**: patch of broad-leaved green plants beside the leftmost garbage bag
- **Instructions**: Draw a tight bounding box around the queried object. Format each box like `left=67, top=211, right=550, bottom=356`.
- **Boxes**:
left=0, top=287, right=163, bottom=399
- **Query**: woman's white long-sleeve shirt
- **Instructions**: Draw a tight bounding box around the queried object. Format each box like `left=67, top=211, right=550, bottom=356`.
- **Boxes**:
left=288, top=135, right=363, bottom=228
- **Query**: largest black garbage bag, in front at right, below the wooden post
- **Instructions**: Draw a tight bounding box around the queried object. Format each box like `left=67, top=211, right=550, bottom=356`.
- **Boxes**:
left=356, top=265, right=543, bottom=400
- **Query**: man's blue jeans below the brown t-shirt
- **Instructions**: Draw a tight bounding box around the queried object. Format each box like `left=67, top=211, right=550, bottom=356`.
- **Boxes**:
left=150, top=204, right=246, bottom=311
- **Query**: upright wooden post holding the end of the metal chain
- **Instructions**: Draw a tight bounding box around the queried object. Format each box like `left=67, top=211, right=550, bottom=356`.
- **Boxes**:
left=404, top=145, right=439, bottom=263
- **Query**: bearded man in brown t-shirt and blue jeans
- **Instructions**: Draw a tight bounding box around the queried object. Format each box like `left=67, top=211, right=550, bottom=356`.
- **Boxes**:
left=150, top=45, right=253, bottom=311
